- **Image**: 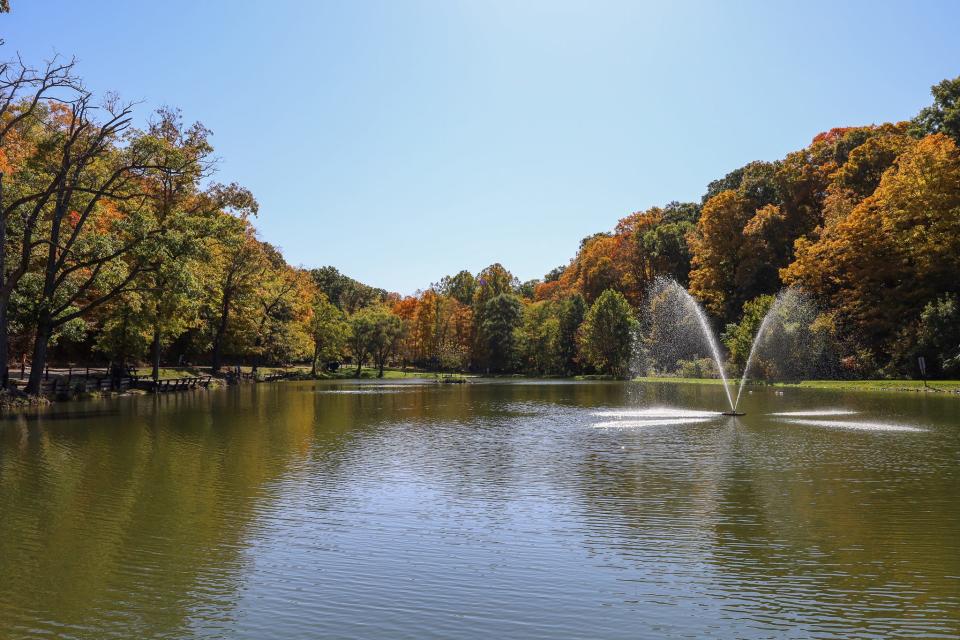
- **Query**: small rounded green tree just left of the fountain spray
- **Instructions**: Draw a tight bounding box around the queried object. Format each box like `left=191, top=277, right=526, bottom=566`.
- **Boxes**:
left=580, top=289, right=637, bottom=377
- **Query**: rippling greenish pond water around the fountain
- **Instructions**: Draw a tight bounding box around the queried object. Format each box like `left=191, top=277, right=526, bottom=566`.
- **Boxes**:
left=0, top=381, right=960, bottom=639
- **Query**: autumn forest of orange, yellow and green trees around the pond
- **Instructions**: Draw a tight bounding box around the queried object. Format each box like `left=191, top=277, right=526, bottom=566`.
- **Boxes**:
left=0, top=47, right=960, bottom=393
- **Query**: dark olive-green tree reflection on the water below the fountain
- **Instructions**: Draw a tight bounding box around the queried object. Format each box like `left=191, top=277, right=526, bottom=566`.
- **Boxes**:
left=712, top=420, right=960, bottom=633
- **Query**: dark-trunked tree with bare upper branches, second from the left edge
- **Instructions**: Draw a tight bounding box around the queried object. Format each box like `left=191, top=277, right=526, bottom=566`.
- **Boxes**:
left=21, top=95, right=188, bottom=393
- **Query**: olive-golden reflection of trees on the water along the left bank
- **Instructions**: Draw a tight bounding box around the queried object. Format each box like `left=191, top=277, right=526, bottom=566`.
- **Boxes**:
left=0, top=389, right=313, bottom=637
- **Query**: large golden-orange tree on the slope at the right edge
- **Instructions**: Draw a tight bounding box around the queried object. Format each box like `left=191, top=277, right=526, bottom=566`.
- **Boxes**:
left=783, top=134, right=960, bottom=368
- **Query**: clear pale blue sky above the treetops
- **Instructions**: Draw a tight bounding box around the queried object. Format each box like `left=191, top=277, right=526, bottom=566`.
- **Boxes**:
left=0, top=0, right=960, bottom=293
